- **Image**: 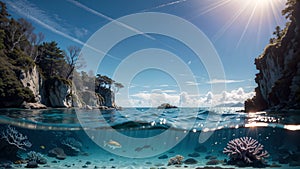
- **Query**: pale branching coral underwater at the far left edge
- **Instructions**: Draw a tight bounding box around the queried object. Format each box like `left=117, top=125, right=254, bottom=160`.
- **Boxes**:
left=1, top=125, right=32, bottom=150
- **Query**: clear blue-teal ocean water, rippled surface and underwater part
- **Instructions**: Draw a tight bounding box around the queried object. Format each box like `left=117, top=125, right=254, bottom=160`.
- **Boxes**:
left=0, top=107, right=300, bottom=169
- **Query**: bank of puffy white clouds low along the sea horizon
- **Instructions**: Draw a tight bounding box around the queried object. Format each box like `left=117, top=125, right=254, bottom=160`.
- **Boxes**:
left=117, top=88, right=254, bottom=107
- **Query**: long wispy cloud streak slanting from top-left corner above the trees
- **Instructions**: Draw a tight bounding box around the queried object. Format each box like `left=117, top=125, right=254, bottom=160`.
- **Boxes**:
left=6, top=0, right=119, bottom=60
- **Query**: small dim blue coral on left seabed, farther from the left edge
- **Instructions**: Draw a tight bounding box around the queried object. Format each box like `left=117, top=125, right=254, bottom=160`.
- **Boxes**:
left=61, top=137, right=82, bottom=155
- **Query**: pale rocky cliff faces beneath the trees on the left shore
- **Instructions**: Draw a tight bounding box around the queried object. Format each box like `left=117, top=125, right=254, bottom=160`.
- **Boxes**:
left=13, top=66, right=115, bottom=108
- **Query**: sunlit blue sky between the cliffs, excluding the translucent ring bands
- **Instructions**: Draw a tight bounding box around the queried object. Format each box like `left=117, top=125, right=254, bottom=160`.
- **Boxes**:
left=4, top=0, right=286, bottom=107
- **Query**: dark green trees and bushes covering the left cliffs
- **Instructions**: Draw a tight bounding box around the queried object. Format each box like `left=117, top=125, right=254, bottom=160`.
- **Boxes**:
left=0, top=1, right=124, bottom=107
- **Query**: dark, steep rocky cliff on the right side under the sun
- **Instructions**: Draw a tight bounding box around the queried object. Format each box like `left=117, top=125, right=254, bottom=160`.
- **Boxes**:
left=245, top=1, right=300, bottom=112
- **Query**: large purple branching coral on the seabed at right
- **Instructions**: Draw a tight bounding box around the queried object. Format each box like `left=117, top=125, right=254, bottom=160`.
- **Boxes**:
left=223, top=137, right=269, bottom=165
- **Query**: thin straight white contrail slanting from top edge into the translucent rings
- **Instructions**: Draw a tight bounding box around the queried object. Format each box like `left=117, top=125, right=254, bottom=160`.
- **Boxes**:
left=67, top=0, right=155, bottom=40
